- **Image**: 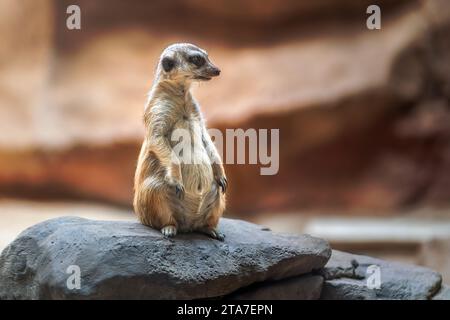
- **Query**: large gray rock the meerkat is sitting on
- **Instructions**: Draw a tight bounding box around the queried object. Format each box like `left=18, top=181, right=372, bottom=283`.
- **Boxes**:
left=0, top=217, right=331, bottom=299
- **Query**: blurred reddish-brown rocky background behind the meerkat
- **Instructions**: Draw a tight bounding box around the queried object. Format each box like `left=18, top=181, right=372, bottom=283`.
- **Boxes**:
left=0, top=0, right=450, bottom=283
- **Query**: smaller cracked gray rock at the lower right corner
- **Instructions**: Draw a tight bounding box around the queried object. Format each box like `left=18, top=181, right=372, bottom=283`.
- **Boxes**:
left=321, top=250, right=442, bottom=300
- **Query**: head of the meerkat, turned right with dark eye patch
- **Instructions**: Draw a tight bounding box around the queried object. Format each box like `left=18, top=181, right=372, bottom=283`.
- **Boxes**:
left=158, top=43, right=220, bottom=81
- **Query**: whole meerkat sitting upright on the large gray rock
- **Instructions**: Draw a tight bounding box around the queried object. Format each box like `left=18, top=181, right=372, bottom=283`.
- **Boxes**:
left=133, top=43, right=228, bottom=241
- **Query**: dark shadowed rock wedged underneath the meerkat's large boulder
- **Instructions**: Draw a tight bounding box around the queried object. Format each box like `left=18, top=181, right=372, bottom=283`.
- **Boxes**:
left=226, top=275, right=323, bottom=300
